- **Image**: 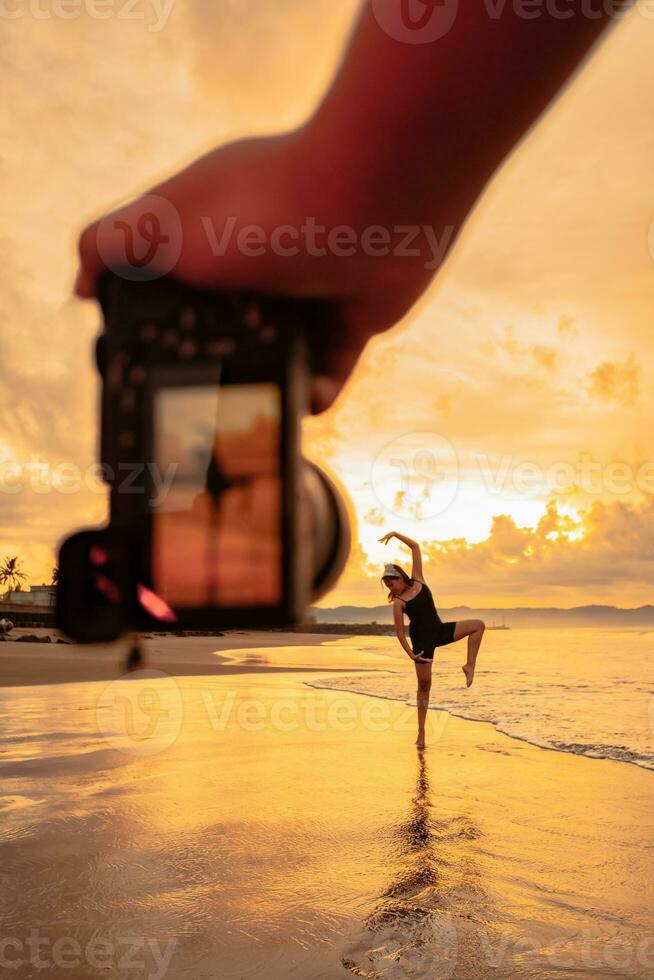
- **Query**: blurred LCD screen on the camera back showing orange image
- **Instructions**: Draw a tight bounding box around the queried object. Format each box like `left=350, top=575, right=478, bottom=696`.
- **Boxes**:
left=151, top=383, right=283, bottom=608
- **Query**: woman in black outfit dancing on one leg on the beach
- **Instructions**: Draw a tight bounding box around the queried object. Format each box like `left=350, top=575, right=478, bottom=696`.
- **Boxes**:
left=379, top=531, right=486, bottom=748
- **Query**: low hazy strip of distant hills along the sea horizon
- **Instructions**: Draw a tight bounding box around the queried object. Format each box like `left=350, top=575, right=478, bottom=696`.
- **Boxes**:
left=309, top=605, right=654, bottom=629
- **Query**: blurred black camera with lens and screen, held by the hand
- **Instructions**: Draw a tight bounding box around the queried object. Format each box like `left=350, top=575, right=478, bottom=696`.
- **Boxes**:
left=56, top=268, right=350, bottom=643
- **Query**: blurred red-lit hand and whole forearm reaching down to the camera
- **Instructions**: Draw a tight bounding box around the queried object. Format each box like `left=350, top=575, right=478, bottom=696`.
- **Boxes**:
left=75, top=0, right=628, bottom=413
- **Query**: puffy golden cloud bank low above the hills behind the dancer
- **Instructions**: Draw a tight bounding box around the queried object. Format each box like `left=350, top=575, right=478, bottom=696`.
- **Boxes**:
left=330, top=496, right=654, bottom=607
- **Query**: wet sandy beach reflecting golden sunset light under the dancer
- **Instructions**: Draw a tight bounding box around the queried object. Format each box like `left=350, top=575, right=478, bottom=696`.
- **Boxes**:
left=0, top=633, right=654, bottom=980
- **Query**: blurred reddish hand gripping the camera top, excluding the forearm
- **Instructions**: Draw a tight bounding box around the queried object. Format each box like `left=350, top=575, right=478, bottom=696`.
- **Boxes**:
left=75, top=129, right=433, bottom=414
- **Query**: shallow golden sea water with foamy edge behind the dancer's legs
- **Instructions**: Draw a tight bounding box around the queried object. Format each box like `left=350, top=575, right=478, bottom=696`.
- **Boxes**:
left=308, top=628, right=654, bottom=769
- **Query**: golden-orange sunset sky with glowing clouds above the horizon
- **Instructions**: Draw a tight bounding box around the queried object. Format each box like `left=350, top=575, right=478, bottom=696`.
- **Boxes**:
left=0, top=0, right=654, bottom=607
